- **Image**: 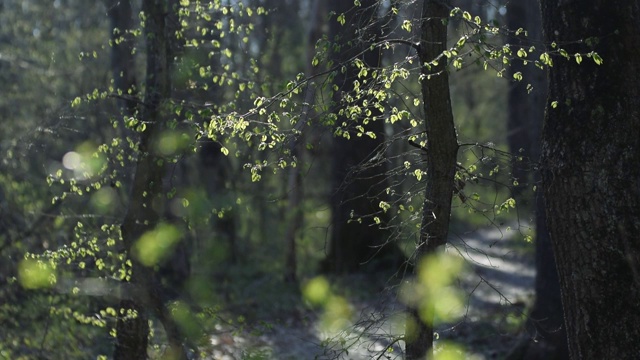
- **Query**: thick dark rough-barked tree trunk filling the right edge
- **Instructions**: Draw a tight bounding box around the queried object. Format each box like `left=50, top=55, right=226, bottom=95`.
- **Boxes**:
left=541, top=0, right=640, bottom=359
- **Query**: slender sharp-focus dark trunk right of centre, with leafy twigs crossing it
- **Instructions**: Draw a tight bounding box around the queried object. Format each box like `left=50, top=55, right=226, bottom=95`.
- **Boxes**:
left=405, top=0, right=458, bottom=359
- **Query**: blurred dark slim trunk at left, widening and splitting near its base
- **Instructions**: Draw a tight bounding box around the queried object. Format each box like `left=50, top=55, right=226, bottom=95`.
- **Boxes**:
left=114, top=0, right=186, bottom=360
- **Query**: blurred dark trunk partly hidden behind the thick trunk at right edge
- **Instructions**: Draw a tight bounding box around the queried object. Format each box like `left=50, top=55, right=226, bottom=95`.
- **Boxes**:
left=507, top=1, right=568, bottom=359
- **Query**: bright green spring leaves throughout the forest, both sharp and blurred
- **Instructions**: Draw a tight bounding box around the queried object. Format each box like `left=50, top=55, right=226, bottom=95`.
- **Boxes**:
left=0, top=0, right=604, bottom=359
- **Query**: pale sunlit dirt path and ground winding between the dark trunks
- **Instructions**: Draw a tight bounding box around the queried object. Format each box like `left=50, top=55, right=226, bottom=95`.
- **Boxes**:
left=204, top=229, right=535, bottom=360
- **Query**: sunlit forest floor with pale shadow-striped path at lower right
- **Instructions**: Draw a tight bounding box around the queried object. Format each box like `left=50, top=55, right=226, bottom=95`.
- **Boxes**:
left=200, top=228, right=535, bottom=360
